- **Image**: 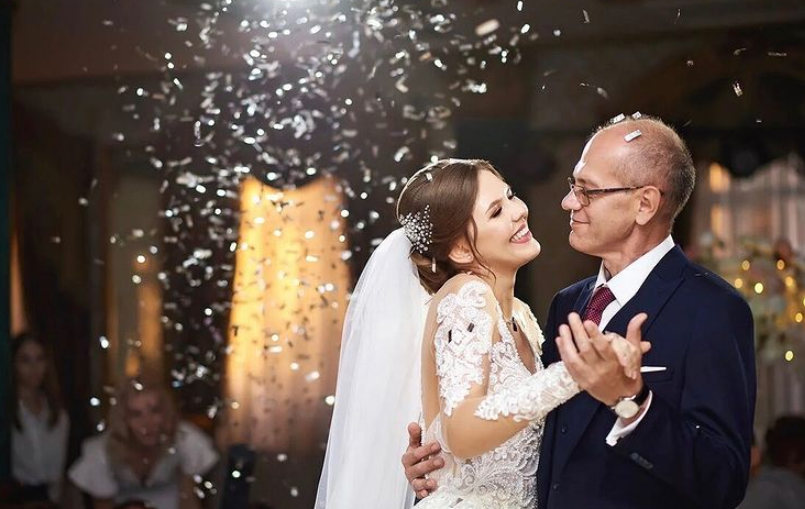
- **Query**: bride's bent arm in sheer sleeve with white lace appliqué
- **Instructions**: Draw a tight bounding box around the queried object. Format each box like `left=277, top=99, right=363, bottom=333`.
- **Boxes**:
left=433, top=281, right=579, bottom=458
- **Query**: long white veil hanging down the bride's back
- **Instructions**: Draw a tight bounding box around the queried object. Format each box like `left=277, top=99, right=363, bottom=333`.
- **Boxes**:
left=315, top=228, right=430, bottom=509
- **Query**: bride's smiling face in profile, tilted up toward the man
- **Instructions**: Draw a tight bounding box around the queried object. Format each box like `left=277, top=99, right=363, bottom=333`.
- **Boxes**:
left=470, top=171, right=541, bottom=274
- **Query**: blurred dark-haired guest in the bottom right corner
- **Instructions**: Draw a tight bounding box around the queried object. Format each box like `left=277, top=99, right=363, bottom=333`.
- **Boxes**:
left=739, top=416, right=805, bottom=509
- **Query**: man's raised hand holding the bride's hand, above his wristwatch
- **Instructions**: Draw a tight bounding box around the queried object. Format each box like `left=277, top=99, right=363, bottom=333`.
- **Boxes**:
left=556, top=313, right=649, bottom=406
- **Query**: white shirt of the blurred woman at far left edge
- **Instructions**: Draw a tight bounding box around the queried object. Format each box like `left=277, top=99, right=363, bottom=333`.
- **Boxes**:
left=11, top=401, right=70, bottom=502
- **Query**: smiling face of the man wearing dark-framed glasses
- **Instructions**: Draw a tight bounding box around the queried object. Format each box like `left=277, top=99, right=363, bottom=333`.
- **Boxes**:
left=562, top=126, right=640, bottom=258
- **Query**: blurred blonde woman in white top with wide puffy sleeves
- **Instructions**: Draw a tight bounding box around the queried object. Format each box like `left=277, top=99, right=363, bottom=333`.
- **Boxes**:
left=69, top=377, right=218, bottom=509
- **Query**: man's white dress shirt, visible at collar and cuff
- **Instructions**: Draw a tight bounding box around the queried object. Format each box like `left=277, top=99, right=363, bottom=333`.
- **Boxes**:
left=594, top=235, right=674, bottom=445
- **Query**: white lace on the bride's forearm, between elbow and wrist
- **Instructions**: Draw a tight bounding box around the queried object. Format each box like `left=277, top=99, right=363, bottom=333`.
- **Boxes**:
left=475, top=362, right=579, bottom=421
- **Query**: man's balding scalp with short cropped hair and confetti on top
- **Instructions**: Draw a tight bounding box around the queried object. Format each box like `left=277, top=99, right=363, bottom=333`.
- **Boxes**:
left=593, top=115, right=696, bottom=223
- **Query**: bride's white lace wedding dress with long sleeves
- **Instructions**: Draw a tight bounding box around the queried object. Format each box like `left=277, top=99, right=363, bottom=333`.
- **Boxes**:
left=416, top=280, right=579, bottom=509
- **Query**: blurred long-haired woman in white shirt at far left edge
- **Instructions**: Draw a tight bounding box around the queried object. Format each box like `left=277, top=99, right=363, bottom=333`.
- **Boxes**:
left=9, top=332, right=70, bottom=504
